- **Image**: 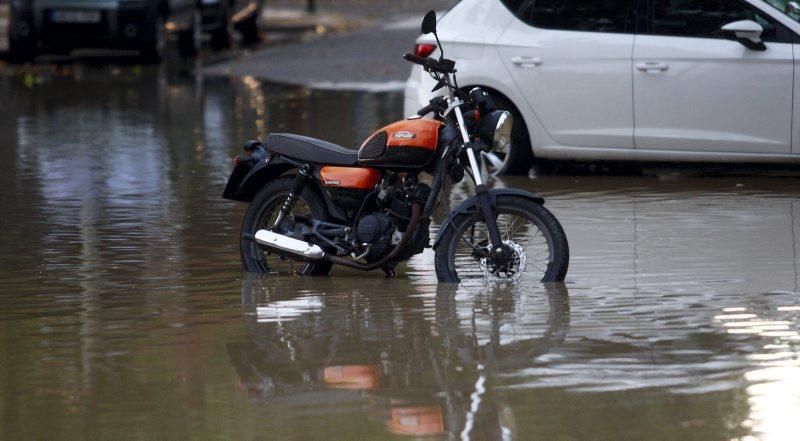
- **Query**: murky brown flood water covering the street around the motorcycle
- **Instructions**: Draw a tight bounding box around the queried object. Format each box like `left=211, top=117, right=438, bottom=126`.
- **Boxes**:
left=0, top=65, right=800, bottom=440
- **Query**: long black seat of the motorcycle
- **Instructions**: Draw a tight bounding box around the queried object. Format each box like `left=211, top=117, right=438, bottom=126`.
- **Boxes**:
left=264, top=133, right=358, bottom=165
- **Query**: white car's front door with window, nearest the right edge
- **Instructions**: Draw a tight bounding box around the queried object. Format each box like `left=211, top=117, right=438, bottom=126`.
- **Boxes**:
left=633, top=0, right=794, bottom=154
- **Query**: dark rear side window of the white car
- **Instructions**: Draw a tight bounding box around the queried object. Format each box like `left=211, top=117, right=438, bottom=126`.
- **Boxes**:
left=502, top=0, right=634, bottom=33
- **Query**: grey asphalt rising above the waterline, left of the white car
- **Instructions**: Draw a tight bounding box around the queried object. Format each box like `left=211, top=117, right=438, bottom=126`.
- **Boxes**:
left=204, top=0, right=462, bottom=88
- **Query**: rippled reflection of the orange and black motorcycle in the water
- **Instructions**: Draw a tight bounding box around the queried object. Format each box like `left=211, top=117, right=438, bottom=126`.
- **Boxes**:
left=227, top=279, right=569, bottom=439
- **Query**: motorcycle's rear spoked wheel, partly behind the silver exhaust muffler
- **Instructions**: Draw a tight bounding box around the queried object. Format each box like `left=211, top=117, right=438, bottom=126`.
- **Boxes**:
left=240, top=178, right=331, bottom=275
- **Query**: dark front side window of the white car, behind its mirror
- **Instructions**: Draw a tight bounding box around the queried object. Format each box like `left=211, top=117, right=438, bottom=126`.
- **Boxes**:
left=650, top=0, right=792, bottom=43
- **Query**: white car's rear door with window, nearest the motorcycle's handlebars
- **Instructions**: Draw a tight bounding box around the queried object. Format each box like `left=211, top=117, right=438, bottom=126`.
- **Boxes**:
left=496, top=0, right=635, bottom=149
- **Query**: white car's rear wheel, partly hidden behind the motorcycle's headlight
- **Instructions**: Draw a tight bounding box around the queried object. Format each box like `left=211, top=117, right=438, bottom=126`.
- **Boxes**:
left=484, top=95, right=534, bottom=175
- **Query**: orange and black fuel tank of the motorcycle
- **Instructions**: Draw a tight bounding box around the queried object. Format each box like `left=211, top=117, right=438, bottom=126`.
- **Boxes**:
left=358, top=118, right=444, bottom=168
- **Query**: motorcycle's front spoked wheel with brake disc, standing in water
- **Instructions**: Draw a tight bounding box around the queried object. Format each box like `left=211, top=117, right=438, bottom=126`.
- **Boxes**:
left=436, top=197, right=569, bottom=284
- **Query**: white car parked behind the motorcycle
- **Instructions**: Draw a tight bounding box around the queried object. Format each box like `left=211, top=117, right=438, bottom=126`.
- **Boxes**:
left=405, top=0, right=800, bottom=173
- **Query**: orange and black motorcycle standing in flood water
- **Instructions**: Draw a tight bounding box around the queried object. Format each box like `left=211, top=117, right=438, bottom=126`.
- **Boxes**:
left=223, top=11, right=569, bottom=283
